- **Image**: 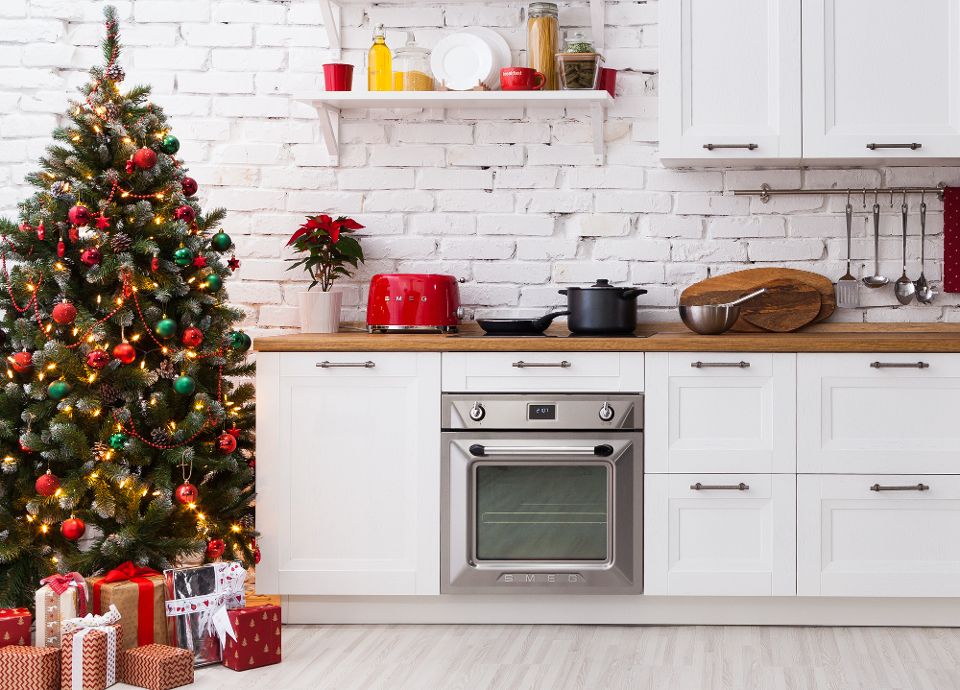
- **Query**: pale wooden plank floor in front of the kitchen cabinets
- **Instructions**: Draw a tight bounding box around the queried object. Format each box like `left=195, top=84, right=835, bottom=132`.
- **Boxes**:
left=115, top=625, right=960, bottom=690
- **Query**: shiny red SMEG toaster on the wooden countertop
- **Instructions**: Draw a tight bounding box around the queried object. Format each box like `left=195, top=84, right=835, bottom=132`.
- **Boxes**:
left=367, top=273, right=463, bottom=333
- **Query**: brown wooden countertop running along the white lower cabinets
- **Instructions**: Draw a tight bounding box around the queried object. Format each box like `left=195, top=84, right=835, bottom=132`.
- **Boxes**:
left=254, top=323, right=960, bottom=352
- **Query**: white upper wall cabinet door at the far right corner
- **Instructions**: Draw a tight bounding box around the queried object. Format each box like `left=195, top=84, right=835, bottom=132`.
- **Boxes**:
left=803, top=0, right=960, bottom=162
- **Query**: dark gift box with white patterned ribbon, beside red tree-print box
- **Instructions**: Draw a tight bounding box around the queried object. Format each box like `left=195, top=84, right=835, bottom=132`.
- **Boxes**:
left=163, top=561, right=247, bottom=666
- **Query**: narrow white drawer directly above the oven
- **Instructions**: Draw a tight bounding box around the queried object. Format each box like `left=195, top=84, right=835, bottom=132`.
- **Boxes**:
left=442, top=352, right=643, bottom=393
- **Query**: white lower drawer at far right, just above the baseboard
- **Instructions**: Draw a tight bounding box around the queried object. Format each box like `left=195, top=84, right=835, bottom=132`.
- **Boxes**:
left=797, top=474, right=960, bottom=597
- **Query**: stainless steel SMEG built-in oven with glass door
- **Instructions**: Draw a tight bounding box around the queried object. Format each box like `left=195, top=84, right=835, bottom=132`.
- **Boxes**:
left=440, top=393, right=643, bottom=594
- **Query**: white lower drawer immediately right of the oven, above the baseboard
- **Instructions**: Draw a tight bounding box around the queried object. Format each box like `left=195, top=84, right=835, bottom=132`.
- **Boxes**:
left=644, top=474, right=796, bottom=596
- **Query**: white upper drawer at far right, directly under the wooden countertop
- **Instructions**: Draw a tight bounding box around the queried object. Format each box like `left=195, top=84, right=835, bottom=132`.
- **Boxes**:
left=797, top=353, right=960, bottom=474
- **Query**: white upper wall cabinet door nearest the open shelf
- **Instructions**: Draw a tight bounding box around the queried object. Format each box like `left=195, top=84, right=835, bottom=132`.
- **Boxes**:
left=659, top=0, right=801, bottom=164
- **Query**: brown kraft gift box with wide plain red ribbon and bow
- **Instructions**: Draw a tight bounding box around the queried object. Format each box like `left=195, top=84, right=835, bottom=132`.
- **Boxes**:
left=87, top=561, right=167, bottom=649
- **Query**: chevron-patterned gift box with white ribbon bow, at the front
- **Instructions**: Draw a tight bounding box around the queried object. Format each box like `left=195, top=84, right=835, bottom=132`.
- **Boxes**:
left=60, top=605, right=123, bottom=690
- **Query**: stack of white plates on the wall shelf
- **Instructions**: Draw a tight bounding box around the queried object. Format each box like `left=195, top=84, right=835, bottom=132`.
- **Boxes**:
left=430, top=26, right=510, bottom=91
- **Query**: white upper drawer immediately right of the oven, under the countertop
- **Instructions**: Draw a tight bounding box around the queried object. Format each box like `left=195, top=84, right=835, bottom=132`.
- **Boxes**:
left=645, top=352, right=796, bottom=473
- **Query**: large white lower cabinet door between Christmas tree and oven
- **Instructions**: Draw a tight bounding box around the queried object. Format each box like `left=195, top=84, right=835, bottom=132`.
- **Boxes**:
left=251, top=352, right=440, bottom=595
